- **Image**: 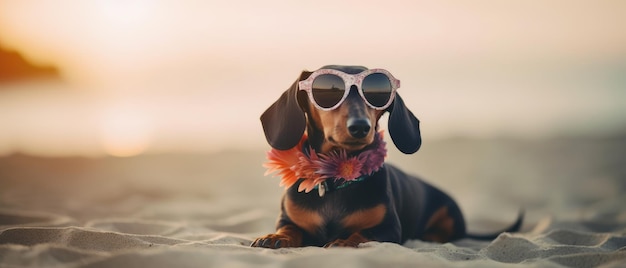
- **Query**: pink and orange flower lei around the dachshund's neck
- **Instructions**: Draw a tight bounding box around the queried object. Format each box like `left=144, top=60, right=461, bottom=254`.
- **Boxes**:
left=263, top=131, right=387, bottom=195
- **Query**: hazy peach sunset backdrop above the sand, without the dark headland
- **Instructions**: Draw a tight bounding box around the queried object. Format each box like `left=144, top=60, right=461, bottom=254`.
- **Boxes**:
left=0, top=0, right=626, bottom=156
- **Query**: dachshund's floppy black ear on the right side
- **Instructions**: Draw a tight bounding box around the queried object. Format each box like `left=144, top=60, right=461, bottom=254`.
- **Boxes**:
left=387, top=94, right=422, bottom=154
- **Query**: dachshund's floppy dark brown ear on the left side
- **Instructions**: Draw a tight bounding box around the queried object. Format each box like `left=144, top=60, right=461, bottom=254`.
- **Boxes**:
left=261, top=71, right=311, bottom=150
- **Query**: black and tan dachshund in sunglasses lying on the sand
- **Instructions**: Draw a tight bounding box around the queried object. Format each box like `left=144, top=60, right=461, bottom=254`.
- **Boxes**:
left=251, top=65, right=523, bottom=248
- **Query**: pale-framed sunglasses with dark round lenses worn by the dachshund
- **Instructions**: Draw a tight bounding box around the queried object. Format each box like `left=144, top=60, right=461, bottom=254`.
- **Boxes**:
left=298, top=69, right=400, bottom=111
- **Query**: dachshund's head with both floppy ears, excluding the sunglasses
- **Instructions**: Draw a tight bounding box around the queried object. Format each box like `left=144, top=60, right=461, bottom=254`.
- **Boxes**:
left=261, top=65, right=422, bottom=154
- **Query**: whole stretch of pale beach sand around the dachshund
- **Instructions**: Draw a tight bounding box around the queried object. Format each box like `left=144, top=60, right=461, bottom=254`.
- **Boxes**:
left=0, top=138, right=626, bottom=267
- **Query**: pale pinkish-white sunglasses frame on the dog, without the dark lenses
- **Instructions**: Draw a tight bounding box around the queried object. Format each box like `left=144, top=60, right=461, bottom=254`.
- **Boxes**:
left=298, top=69, right=400, bottom=111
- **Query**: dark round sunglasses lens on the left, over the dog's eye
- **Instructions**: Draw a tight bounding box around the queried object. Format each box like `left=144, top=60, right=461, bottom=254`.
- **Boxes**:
left=312, top=74, right=346, bottom=108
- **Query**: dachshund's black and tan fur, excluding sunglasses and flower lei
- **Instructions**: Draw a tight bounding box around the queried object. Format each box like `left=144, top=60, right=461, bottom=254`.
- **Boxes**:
left=252, top=66, right=522, bottom=248
